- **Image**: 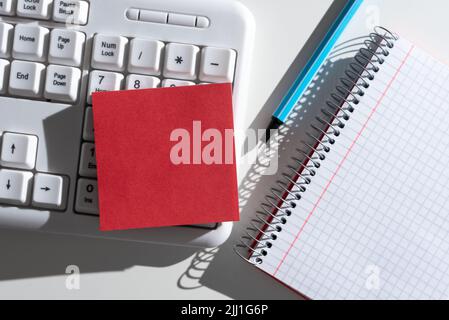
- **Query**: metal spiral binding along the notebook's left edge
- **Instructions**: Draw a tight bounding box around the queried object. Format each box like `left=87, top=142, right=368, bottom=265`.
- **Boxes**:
left=234, top=27, right=399, bottom=264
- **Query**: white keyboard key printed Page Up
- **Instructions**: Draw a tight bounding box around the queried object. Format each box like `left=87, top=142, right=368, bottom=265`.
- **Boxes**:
left=48, top=29, right=86, bottom=67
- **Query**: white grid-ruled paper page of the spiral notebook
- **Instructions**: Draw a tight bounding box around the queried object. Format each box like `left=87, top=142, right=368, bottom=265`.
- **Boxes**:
left=260, top=40, right=449, bottom=299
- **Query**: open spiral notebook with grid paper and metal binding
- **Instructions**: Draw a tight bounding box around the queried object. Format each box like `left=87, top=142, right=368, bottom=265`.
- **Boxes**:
left=238, top=28, right=449, bottom=300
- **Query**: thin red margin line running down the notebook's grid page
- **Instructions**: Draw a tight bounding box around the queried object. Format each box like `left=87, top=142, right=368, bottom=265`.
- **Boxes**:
left=273, top=45, right=415, bottom=277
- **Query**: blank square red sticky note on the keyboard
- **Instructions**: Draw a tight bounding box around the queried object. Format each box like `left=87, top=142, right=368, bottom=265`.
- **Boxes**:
left=93, top=84, right=239, bottom=231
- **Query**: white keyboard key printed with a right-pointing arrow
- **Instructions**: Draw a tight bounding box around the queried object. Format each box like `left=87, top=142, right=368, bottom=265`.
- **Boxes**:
left=31, top=173, right=67, bottom=210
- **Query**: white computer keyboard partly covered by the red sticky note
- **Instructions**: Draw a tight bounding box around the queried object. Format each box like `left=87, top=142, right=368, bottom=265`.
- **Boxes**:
left=0, top=0, right=254, bottom=247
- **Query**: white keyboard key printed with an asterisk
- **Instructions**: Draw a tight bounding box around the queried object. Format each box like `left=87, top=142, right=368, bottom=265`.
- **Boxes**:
left=164, top=43, right=200, bottom=80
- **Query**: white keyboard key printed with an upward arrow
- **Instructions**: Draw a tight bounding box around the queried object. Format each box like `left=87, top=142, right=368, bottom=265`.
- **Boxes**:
left=0, top=133, right=38, bottom=170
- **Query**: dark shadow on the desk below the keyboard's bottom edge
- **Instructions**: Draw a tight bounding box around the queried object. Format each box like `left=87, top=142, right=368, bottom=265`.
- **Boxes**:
left=0, top=230, right=197, bottom=281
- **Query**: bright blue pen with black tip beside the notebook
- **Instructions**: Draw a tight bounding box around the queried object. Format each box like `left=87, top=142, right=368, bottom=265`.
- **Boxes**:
left=268, top=0, right=363, bottom=131
